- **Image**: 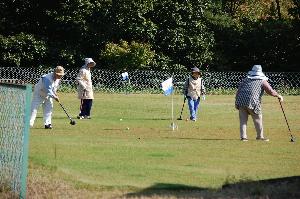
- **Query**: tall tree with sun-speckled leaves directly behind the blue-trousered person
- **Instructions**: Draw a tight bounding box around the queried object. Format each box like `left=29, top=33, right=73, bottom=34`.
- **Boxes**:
left=153, top=0, right=214, bottom=68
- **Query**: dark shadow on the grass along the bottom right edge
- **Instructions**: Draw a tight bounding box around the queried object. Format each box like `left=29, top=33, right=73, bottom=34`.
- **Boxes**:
left=124, top=176, right=300, bottom=199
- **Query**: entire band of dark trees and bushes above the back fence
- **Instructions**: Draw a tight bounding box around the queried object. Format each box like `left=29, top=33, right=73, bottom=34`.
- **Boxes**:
left=0, top=0, right=300, bottom=71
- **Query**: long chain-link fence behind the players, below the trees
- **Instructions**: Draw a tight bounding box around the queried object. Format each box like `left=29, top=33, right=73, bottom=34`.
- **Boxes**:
left=0, top=67, right=300, bottom=95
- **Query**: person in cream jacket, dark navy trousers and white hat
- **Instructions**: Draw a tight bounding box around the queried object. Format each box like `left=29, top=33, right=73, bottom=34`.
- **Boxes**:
left=76, top=58, right=96, bottom=119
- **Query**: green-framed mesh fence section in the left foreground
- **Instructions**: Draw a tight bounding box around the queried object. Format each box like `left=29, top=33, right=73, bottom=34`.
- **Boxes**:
left=0, top=83, right=32, bottom=198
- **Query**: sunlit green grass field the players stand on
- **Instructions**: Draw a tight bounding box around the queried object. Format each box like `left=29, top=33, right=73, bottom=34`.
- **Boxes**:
left=28, top=93, right=300, bottom=198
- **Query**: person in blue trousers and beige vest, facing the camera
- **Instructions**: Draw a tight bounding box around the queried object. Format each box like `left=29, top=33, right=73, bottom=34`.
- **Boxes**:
left=183, top=67, right=205, bottom=121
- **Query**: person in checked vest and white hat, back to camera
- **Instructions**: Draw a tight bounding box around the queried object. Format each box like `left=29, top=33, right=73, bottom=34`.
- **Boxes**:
left=235, top=65, right=283, bottom=141
